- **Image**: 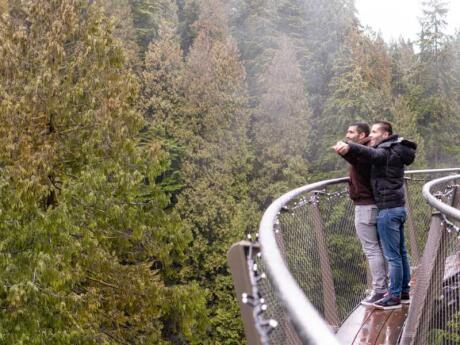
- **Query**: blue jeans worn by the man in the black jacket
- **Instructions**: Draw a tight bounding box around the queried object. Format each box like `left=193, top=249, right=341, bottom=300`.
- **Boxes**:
left=377, top=207, right=410, bottom=297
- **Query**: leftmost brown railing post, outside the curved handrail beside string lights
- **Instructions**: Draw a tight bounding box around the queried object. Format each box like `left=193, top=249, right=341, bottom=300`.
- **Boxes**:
left=227, top=241, right=262, bottom=345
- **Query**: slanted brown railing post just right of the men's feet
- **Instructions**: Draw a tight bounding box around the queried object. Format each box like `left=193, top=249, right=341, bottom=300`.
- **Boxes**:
left=400, top=211, right=448, bottom=345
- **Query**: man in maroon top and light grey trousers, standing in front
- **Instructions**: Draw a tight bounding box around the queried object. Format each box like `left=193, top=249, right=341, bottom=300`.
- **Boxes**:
left=344, top=122, right=387, bottom=305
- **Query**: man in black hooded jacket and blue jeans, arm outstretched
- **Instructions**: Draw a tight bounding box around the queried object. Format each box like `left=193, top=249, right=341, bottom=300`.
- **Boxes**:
left=334, top=121, right=417, bottom=309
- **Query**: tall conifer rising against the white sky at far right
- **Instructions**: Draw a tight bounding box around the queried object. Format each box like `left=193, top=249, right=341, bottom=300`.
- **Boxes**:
left=410, top=0, right=460, bottom=166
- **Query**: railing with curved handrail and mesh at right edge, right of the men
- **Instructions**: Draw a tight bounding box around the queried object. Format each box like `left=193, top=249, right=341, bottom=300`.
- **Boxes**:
left=400, top=175, right=460, bottom=345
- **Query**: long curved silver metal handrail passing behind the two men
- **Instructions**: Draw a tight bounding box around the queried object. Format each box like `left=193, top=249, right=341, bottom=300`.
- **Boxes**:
left=259, top=168, right=460, bottom=345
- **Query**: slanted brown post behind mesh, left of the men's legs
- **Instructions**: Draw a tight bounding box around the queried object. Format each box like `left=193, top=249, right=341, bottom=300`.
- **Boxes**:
left=311, top=195, right=339, bottom=327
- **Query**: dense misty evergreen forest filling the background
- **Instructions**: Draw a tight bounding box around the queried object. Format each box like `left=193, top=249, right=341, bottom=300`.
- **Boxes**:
left=0, top=0, right=460, bottom=345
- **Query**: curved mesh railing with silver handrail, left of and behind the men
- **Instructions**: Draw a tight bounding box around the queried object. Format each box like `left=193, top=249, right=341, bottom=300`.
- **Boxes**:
left=229, top=169, right=460, bottom=345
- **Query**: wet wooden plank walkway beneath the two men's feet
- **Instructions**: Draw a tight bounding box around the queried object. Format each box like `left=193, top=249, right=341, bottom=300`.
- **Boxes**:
left=337, top=304, right=409, bottom=345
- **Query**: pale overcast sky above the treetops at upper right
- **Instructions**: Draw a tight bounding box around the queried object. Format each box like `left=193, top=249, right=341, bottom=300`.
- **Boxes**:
left=355, top=0, right=460, bottom=42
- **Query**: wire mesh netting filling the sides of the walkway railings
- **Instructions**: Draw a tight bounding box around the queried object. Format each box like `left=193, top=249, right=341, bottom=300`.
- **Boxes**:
left=248, top=173, right=460, bottom=345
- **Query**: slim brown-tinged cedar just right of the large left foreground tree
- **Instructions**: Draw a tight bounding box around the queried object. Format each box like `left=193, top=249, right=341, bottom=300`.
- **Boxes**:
left=142, top=4, right=188, bottom=201
